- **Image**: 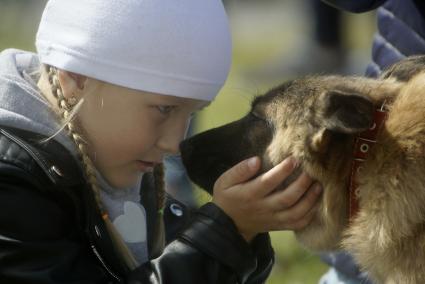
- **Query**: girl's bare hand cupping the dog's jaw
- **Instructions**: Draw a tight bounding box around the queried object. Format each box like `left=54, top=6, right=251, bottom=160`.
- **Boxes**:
left=213, top=157, right=322, bottom=242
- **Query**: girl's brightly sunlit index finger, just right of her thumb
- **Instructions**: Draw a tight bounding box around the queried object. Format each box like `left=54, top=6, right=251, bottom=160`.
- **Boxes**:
left=249, top=157, right=296, bottom=198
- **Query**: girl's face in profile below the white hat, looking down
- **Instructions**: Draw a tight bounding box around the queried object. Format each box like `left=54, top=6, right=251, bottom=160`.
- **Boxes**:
left=78, top=82, right=206, bottom=188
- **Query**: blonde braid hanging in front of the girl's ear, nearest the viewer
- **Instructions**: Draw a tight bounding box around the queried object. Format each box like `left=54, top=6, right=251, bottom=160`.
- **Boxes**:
left=46, top=66, right=138, bottom=270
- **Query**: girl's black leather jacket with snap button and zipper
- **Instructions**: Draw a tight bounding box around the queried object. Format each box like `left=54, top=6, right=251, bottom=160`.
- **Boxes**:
left=0, top=128, right=273, bottom=284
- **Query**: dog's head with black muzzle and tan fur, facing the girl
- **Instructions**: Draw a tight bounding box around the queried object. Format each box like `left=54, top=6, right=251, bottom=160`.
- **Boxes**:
left=181, top=73, right=399, bottom=249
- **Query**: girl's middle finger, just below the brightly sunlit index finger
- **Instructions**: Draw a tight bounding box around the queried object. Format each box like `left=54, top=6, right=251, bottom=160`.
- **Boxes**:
left=264, top=173, right=313, bottom=211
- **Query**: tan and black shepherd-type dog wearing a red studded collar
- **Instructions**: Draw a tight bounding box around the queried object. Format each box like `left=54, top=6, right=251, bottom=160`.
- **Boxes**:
left=181, top=57, right=425, bottom=284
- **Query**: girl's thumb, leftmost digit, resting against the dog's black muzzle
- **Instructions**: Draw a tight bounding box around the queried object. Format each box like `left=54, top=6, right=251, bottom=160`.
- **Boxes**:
left=214, top=157, right=260, bottom=192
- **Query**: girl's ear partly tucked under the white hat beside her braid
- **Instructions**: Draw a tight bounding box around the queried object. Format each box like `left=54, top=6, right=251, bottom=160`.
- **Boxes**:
left=58, top=70, right=87, bottom=100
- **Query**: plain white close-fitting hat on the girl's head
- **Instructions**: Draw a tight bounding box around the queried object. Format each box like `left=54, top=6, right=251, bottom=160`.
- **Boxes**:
left=36, top=0, right=231, bottom=101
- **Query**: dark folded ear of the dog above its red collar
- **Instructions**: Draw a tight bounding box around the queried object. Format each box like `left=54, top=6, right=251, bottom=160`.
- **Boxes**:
left=321, top=90, right=375, bottom=134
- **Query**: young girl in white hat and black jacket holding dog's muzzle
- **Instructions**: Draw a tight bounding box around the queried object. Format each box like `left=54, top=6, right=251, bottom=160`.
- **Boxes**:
left=0, top=0, right=320, bottom=284
